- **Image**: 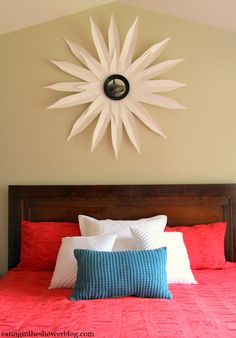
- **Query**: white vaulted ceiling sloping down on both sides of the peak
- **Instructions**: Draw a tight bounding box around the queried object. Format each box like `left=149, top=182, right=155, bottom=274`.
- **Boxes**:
left=0, top=0, right=236, bottom=34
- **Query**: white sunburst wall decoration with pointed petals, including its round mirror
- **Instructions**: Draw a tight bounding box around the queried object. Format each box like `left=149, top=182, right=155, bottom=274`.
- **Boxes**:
left=46, top=16, right=185, bottom=157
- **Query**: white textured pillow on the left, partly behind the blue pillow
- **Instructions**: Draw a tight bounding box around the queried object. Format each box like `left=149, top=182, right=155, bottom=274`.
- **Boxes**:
left=49, top=235, right=116, bottom=289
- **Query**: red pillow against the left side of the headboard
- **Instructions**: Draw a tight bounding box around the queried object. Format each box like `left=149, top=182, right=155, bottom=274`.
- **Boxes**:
left=17, top=221, right=80, bottom=270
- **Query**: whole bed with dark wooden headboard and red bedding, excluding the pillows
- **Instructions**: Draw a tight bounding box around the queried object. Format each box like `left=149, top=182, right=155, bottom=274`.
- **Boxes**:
left=0, top=184, right=236, bottom=338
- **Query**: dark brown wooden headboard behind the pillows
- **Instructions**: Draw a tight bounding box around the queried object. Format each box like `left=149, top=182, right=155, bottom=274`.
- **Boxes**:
left=8, top=184, right=236, bottom=269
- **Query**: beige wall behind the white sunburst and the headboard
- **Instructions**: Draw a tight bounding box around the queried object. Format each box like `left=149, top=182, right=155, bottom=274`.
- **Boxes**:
left=0, top=4, right=236, bottom=273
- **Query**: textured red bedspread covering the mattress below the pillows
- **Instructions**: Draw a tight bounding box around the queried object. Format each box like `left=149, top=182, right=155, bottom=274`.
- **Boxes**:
left=0, top=264, right=236, bottom=338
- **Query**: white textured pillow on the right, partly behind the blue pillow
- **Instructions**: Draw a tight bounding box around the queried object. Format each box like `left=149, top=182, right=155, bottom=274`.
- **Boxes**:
left=130, top=227, right=197, bottom=284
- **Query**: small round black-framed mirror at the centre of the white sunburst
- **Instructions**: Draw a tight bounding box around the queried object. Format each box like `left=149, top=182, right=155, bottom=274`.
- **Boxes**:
left=103, top=74, right=129, bottom=100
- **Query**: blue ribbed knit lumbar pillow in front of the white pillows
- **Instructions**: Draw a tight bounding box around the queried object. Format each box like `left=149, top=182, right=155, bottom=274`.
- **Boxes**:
left=70, top=248, right=172, bottom=300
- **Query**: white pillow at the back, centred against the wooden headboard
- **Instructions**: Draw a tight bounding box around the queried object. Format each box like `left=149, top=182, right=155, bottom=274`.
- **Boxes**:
left=79, top=215, right=167, bottom=251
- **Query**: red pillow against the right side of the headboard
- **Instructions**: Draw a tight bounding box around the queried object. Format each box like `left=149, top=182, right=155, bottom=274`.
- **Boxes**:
left=166, top=222, right=226, bottom=269
